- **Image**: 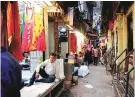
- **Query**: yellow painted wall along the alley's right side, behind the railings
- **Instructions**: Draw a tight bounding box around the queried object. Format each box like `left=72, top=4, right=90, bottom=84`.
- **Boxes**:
left=107, top=3, right=135, bottom=78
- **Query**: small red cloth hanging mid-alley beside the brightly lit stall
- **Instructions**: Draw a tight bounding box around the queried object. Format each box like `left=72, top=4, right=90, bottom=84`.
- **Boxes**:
left=70, top=33, right=77, bottom=52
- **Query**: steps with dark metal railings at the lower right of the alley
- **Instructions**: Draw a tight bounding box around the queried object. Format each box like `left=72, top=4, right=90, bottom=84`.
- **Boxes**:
left=111, top=49, right=135, bottom=97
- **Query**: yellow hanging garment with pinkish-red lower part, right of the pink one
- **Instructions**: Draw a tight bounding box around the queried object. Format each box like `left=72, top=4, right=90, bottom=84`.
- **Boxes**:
left=31, top=9, right=46, bottom=51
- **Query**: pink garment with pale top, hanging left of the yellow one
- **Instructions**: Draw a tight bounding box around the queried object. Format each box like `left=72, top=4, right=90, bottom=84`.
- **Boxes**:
left=22, top=8, right=34, bottom=52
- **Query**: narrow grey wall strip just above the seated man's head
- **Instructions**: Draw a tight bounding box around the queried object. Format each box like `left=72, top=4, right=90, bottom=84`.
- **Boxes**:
left=48, top=22, right=54, bottom=54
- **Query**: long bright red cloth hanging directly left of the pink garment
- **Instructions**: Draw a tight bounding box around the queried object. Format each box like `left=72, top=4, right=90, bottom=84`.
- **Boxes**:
left=9, top=1, right=23, bottom=60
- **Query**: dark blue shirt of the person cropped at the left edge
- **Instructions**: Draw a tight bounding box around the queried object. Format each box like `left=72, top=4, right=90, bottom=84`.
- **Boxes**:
left=1, top=47, right=22, bottom=97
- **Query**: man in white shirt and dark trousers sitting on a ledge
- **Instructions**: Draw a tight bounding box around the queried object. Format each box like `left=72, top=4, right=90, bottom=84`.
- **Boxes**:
left=28, top=53, right=60, bottom=86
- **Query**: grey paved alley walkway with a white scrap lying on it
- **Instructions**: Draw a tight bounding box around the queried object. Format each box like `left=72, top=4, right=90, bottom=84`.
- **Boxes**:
left=60, top=65, right=116, bottom=97
